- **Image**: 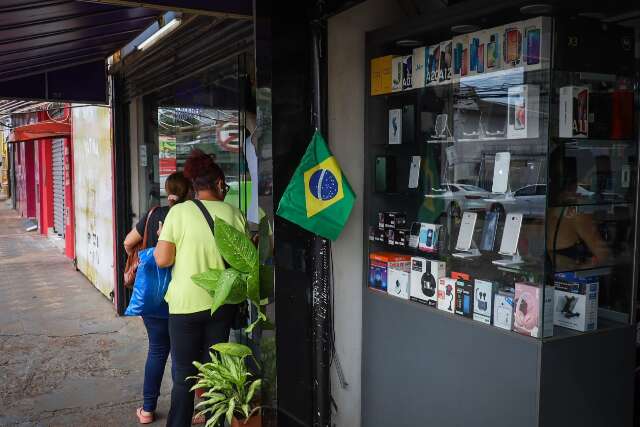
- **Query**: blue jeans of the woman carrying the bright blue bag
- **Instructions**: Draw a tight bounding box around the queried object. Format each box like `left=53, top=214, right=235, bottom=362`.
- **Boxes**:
left=142, top=316, right=173, bottom=412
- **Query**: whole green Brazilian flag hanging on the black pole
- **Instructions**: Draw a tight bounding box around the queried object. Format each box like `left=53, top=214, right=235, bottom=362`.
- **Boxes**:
left=276, top=131, right=356, bottom=240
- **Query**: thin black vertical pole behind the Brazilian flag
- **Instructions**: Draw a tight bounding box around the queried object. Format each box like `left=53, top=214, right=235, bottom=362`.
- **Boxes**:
left=311, top=12, right=331, bottom=427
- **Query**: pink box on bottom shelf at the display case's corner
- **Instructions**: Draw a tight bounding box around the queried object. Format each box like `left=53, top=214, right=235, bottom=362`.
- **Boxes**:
left=513, top=282, right=554, bottom=338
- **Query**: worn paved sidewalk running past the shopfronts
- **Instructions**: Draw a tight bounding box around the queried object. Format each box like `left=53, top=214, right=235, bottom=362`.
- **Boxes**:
left=0, top=202, right=171, bottom=426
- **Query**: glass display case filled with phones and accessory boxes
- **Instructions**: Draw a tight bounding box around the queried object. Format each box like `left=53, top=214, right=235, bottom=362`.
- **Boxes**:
left=365, top=17, right=638, bottom=339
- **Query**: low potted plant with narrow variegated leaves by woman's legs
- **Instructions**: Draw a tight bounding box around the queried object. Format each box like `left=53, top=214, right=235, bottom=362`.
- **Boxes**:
left=189, top=343, right=262, bottom=427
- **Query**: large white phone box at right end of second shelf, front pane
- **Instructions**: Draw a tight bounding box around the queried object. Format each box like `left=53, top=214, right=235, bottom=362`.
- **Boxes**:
left=507, top=85, right=540, bottom=139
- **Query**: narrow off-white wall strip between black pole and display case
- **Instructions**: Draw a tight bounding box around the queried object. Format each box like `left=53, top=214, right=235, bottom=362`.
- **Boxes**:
left=328, top=0, right=403, bottom=427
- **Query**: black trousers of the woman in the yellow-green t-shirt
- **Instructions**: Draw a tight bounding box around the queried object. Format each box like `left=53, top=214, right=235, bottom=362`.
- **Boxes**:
left=167, top=305, right=238, bottom=427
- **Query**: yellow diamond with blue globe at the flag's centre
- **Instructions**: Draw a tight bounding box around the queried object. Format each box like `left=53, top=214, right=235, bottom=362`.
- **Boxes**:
left=304, top=156, right=344, bottom=218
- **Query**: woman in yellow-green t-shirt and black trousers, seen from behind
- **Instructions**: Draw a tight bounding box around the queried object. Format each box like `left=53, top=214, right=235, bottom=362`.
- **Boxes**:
left=154, top=150, right=246, bottom=427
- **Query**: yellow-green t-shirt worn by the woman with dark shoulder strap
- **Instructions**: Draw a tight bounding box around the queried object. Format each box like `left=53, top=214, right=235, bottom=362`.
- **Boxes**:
left=158, top=200, right=247, bottom=314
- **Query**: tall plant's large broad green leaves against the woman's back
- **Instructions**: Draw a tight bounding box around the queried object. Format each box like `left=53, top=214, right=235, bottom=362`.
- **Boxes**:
left=191, top=218, right=273, bottom=332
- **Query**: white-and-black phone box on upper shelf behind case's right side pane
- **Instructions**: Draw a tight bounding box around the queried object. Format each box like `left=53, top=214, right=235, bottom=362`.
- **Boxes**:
left=558, top=86, right=589, bottom=138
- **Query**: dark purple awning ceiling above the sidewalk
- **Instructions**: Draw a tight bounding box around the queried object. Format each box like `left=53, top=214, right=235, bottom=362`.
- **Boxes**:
left=0, top=0, right=252, bottom=103
